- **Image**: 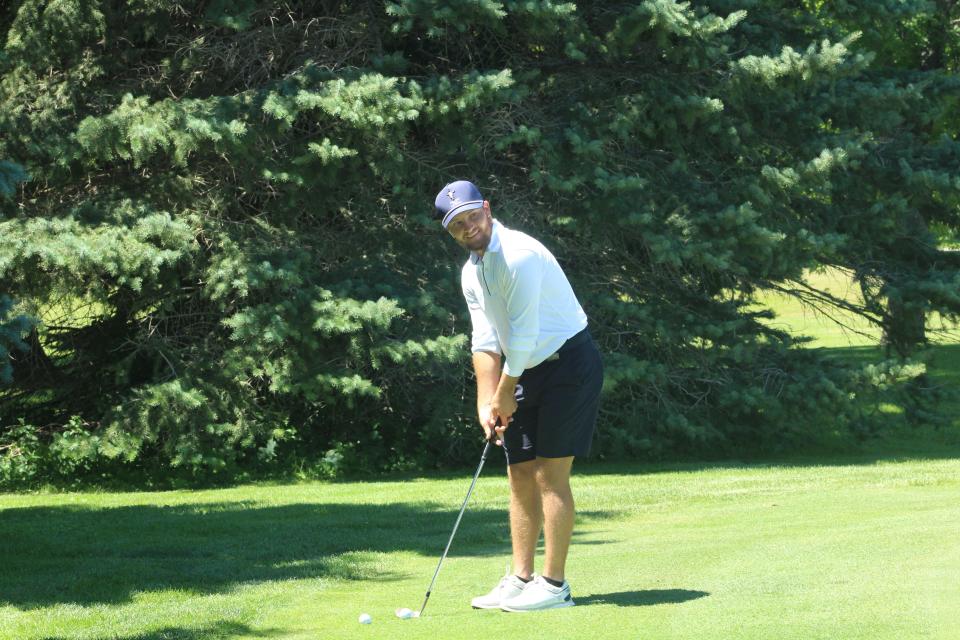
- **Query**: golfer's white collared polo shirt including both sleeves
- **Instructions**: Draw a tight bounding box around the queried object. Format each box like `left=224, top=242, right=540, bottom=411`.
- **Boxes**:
left=460, top=220, right=587, bottom=377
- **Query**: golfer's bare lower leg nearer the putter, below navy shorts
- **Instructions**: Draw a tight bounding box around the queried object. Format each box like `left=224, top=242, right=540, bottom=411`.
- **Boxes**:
left=507, top=460, right=543, bottom=580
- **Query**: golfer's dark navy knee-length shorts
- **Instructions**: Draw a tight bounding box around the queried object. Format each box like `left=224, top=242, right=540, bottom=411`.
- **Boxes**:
left=503, top=329, right=603, bottom=464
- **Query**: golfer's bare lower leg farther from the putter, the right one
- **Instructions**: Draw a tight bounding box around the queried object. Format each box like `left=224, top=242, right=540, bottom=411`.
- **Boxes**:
left=536, top=456, right=575, bottom=582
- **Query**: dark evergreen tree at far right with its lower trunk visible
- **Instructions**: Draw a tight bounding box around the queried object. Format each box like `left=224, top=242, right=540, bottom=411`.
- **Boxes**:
left=756, top=0, right=960, bottom=357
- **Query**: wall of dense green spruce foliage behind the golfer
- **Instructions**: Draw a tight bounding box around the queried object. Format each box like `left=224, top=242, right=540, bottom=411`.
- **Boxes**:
left=0, top=0, right=960, bottom=479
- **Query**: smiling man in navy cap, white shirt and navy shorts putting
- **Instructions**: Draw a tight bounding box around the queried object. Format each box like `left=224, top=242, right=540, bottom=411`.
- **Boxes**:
left=435, top=180, right=603, bottom=611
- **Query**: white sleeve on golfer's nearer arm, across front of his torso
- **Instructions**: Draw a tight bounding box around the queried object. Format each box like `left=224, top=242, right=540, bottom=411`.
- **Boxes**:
left=503, top=251, right=544, bottom=378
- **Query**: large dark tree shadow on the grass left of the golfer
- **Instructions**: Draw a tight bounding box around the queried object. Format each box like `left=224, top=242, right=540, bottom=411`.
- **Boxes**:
left=0, top=502, right=612, bottom=608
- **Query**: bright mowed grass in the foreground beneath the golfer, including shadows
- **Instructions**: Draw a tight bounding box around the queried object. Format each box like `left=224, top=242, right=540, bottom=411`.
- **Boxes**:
left=0, top=459, right=960, bottom=640
